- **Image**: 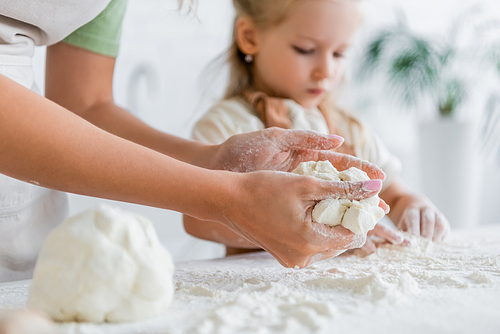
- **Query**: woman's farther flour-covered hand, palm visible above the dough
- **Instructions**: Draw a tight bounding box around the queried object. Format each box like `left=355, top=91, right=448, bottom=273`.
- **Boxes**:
left=209, top=128, right=385, bottom=180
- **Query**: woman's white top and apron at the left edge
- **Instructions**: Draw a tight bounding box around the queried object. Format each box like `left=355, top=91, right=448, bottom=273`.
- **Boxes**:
left=0, top=0, right=110, bottom=282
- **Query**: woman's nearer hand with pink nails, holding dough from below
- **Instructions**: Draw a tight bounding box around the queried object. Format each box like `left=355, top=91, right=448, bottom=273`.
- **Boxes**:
left=220, top=171, right=382, bottom=268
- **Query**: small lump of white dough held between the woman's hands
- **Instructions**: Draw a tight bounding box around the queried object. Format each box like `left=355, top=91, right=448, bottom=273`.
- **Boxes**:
left=292, top=161, right=385, bottom=234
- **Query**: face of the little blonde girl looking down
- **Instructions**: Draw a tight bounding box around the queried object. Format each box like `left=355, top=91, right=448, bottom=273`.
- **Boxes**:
left=253, top=0, right=361, bottom=108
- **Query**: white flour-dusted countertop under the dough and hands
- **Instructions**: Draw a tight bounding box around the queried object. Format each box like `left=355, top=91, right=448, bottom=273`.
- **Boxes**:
left=0, top=224, right=500, bottom=334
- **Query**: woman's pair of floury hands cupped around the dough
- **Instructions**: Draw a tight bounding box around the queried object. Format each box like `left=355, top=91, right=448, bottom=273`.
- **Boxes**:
left=199, top=128, right=385, bottom=268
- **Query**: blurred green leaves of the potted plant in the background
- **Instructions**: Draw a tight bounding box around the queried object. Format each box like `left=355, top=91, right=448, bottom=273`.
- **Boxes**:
left=357, top=11, right=500, bottom=117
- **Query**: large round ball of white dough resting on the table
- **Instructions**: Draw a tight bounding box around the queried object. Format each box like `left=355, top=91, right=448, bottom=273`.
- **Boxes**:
left=27, top=205, right=174, bottom=322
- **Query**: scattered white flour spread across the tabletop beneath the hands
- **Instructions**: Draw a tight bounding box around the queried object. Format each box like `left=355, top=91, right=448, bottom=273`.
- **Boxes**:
left=171, top=230, right=500, bottom=333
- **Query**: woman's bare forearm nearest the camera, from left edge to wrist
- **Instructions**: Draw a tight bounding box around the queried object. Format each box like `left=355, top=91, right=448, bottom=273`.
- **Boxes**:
left=0, top=76, right=230, bottom=220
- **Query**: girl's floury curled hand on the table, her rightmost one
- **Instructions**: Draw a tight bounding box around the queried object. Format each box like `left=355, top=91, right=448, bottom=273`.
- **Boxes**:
left=389, top=194, right=450, bottom=241
